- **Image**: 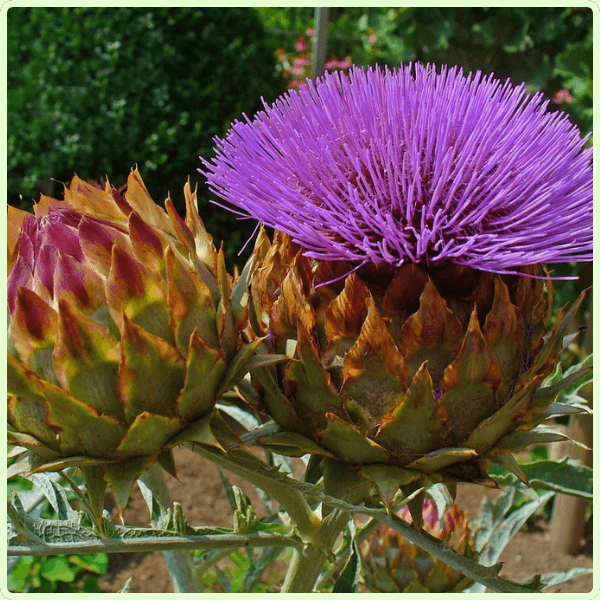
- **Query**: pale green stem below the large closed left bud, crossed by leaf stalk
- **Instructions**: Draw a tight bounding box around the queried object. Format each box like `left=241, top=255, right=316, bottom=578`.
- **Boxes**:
left=141, top=464, right=200, bottom=594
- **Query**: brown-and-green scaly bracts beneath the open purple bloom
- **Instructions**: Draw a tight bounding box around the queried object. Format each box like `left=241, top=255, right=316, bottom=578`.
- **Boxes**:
left=241, top=232, right=581, bottom=504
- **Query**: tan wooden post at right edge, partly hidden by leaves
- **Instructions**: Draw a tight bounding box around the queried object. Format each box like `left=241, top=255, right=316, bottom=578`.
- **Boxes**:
left=550, top=288, right=593, bottom=555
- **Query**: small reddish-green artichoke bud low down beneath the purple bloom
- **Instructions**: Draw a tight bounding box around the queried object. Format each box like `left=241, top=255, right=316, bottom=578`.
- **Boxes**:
left=360, top=498, right=475, bottom=594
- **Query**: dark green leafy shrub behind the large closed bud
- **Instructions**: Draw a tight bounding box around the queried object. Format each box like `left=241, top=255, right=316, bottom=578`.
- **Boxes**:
left=7, top=7, right=284, bottom=255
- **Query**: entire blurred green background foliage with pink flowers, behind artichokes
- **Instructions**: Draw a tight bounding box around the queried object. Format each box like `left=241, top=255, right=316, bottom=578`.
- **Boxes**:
left=7, top=7, right=592, bottom=276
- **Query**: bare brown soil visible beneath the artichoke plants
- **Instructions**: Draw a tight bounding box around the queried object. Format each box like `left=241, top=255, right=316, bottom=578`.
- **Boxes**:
left=100, top=449, right=593, bottom=593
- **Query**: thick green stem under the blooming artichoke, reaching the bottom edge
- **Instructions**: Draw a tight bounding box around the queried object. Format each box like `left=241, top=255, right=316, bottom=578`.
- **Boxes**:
left=281, top=509, right=350, bottom=594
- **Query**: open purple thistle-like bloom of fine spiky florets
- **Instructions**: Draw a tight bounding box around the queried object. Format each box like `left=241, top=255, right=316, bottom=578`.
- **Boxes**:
left=200, top=64, right=592, bottom=273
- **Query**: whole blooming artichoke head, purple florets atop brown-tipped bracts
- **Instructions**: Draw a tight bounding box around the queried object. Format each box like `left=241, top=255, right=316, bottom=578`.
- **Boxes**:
left=203, top=64, right=592, bottom=503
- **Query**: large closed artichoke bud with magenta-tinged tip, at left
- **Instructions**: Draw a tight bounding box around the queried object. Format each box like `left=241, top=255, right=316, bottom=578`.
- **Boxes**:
left=8, top=170, right=257, bottom=507
